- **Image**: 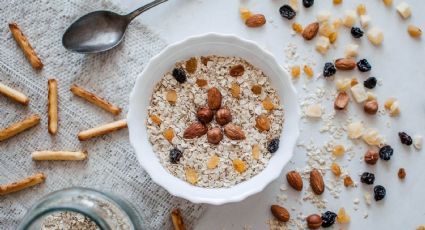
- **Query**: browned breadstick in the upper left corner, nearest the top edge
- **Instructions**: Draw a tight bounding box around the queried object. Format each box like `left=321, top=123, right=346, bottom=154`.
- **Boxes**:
left=9, top=22, right=43, bottom=70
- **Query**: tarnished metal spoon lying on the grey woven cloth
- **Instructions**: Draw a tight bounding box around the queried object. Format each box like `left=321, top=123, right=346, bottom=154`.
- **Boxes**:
left=62, top=0, right=168, bottom=53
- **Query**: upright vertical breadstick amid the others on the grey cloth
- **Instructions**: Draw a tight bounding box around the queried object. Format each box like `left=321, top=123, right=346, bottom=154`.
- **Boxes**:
left=47, top=79, right=58, bottom=135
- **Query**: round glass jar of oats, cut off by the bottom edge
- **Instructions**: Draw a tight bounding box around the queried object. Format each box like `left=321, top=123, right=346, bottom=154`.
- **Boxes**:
left=18, top=187, right=142, bottom=230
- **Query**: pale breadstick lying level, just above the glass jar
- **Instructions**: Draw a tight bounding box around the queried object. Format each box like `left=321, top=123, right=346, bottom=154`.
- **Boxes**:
left=31, top=151, right=87, bottom=161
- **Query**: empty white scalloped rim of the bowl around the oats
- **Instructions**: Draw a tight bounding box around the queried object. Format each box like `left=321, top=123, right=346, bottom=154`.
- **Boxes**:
left=128, top=33, right=300, bottom=205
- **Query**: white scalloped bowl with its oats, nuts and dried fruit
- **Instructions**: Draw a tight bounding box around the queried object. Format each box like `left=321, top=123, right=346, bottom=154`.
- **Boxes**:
left=128, top=34, right=300, bottom=205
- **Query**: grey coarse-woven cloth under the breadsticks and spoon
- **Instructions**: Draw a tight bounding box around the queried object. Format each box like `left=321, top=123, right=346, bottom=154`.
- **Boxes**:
left=0, top=0, right=205, bottom=229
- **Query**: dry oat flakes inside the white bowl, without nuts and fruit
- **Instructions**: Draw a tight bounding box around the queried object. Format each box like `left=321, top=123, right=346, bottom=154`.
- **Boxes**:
left=147, top=56, right=284, bottom=187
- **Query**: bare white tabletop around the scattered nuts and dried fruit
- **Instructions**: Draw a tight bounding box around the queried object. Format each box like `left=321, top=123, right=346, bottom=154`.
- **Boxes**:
left=114, top=0, right=425, bottom=229
